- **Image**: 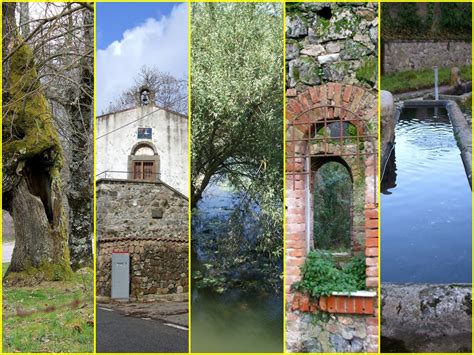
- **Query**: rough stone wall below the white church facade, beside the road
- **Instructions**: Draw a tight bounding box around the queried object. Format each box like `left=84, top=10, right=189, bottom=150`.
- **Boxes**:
left=97, top=179, right=188, bottom=299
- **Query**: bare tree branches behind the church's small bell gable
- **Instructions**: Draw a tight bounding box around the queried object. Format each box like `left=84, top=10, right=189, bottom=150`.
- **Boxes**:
left=102, top=66, right=188, bottom=115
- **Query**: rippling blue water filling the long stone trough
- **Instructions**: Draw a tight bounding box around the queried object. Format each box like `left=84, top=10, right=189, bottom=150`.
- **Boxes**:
left=380, top=109, right=471, bottom=283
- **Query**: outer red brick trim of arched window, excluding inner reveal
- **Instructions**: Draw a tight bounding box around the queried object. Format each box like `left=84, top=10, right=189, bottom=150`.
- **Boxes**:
left=285, top=83, right=379, bottom=308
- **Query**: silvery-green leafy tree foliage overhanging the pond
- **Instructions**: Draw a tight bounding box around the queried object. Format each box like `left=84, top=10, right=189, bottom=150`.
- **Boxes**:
left=191, top=3, right=283, bottom=290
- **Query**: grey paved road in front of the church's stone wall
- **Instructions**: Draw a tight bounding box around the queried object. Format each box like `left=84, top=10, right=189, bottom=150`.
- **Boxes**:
left=97, top=307, right=188, bottom=353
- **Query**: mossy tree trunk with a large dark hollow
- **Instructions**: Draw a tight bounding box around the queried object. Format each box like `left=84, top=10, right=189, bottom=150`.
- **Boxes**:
left=2, top=3, right=72, bottom=283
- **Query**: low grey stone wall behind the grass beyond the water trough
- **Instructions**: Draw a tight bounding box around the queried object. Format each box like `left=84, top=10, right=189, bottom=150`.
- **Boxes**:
left=382, top=41, right=472, bottom=74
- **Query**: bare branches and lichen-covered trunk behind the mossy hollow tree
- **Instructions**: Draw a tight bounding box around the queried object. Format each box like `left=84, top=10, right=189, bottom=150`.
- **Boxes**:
left=2, top=2, right=94, bottom=268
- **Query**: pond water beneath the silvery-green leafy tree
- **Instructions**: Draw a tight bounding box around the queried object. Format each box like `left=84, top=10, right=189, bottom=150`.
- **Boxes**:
left=191, top=184, right=283, bottom=352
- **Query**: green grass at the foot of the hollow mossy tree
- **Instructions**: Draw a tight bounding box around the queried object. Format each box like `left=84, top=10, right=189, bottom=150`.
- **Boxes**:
left=2, top=263, right=94, bottom=353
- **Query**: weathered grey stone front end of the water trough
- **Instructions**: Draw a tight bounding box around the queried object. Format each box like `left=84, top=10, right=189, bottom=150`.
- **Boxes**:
left=381, top=283, right=472, bottom=353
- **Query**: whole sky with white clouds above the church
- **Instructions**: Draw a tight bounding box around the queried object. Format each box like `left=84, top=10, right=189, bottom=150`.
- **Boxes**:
left=96, top=2, right=188, bottom=114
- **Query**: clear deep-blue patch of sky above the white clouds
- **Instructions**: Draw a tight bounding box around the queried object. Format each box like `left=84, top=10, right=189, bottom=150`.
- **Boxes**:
left=96, top=2, right=175, bottom=49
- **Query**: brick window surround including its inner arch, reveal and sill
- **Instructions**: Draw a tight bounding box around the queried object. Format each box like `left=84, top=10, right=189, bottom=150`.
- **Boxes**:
left=285, top=83, right=378, bottom=344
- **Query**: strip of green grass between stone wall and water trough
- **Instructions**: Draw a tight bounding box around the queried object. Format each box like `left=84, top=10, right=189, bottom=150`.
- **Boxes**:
left=380, top=65, right=472, bottom=94
